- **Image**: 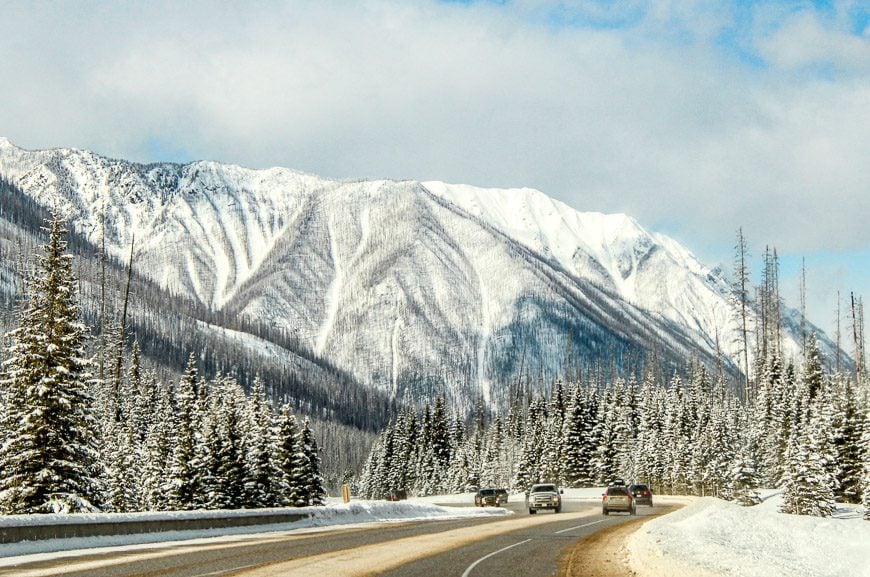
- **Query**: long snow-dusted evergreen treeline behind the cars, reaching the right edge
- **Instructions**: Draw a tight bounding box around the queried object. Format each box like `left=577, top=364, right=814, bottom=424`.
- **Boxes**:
left=359, top=335, right=870, bottom=516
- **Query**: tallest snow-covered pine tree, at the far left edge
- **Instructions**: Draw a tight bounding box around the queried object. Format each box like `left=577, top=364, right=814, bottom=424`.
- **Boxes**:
left=0, top=214, right=101, bottom=513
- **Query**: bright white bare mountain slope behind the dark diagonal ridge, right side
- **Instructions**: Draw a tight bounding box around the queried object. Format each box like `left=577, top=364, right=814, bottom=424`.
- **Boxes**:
left=425, top=182, right=736, bottom=354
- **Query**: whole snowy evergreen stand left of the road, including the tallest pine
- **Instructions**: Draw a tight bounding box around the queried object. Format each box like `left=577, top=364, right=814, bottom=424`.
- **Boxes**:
left=0, top=217, right=325, bottom=514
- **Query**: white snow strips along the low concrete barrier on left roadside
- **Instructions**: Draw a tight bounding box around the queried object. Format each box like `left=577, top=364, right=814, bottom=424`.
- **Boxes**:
left=0, top=496, right=511, bottom=567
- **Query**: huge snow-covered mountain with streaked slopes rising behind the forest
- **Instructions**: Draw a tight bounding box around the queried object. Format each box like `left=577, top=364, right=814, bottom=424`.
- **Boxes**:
left=0, top=139, right=836, bottom=410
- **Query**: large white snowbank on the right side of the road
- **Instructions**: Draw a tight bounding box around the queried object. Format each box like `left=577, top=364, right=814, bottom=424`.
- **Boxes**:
left=628, top=495, right=870, bottom=577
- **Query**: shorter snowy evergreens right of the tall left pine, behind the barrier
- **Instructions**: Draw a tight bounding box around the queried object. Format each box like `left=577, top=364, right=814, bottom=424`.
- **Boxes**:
left=97, top=348, right=325, bottom=511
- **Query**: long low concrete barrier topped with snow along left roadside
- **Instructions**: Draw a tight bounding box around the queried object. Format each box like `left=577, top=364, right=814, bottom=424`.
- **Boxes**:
left=0, top=510, right=309, bottom=543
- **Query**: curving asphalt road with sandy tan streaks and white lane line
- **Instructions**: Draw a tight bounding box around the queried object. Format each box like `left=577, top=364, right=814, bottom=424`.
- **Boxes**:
left=0, top=500, right=655, bottom=577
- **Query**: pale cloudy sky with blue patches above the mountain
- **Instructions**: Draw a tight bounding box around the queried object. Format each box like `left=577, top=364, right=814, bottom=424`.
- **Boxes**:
left=0, top=0, right=870, bottom=340
